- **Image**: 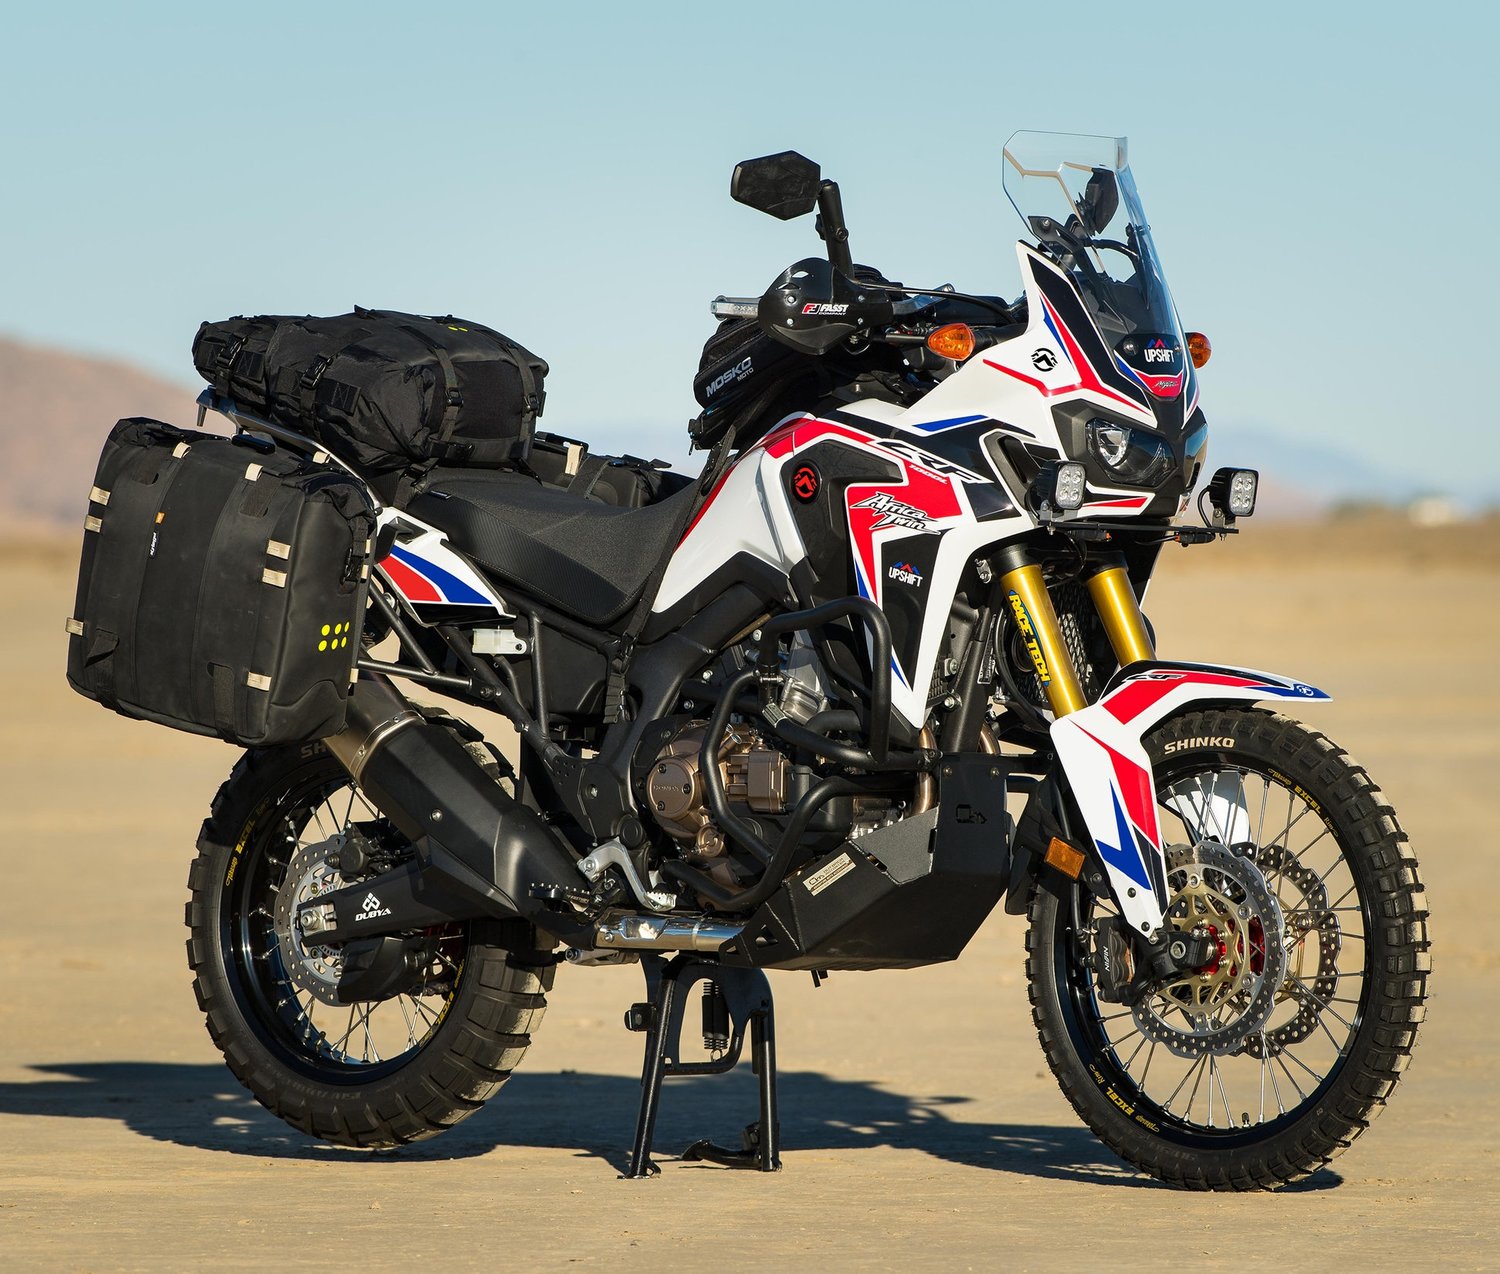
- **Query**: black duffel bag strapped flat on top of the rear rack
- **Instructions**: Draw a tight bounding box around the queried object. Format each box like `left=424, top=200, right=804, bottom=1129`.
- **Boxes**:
left=192, top=308, right=548, bottom=474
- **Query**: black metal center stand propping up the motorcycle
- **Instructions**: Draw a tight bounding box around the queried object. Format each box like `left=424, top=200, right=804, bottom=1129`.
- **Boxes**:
left=624, top=951, right=782, bottom=1178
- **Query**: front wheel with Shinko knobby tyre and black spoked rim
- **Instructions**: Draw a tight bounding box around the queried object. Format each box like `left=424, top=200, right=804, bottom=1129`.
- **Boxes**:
left=1026, top=708, right=1430, bottom=1190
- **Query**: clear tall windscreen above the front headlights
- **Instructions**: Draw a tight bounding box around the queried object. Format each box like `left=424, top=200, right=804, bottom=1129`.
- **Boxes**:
left=1005, top=132, right=1185, bottom=383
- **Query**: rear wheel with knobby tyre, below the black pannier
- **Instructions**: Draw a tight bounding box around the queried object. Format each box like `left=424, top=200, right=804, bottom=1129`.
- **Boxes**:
left=188, top=744, right=554, bottom=1148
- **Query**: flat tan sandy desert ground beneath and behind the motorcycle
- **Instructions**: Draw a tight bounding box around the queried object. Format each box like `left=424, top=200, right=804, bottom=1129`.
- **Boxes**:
left=0, top=521, right=1500, bottom=1271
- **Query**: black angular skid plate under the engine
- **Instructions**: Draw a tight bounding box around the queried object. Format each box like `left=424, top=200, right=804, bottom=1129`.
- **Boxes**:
left=722, top=753, right=1014, bottom=969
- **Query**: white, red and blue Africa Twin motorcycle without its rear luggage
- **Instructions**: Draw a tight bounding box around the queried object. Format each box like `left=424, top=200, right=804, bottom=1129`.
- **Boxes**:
left=175, top=134, right=1428, bottom=1190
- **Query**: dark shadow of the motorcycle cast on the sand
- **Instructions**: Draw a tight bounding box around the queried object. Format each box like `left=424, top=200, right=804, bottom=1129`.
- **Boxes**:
left=0, top=1062, right=1343, bottom=1190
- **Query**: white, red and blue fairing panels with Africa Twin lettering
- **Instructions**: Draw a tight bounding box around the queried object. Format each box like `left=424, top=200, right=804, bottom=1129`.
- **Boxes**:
left=653, top=245, right=1197, bottom=729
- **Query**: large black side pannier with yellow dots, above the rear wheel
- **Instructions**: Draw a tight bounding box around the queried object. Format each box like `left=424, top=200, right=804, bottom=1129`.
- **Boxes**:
left=68, top=419, right=375, bottom=746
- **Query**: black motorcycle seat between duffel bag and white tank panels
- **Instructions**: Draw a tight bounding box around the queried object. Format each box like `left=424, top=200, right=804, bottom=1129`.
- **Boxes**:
left=407, top=470, right=696, bottom=626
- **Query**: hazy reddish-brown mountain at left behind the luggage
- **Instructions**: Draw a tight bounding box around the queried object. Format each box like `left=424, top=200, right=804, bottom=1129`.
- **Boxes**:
left=0, top=338, right=198, bottom=530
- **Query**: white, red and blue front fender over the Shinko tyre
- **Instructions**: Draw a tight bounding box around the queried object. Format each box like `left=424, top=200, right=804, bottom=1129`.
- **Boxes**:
left=1052, top=660, right=1329, bottom=936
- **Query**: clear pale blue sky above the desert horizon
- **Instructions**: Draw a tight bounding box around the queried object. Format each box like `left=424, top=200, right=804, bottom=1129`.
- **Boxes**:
left=0, top=0, right=1500, bottom=501
